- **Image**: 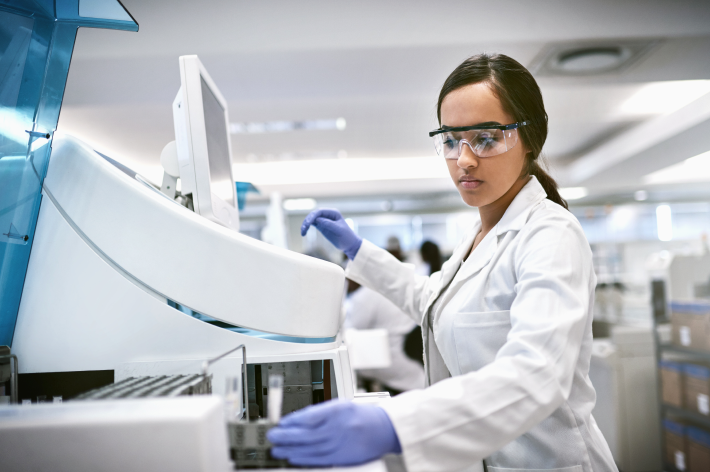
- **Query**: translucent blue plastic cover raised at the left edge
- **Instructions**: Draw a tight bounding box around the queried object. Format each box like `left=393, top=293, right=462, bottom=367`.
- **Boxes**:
left=0, top=0, right=138, bottom=345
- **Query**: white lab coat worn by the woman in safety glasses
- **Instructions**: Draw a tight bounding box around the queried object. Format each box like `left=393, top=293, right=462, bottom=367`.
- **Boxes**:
left=346, top=177, right=617, bottom=472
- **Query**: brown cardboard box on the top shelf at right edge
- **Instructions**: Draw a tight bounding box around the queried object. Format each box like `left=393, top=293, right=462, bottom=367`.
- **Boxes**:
left=671, top=301, right=710, bottom=351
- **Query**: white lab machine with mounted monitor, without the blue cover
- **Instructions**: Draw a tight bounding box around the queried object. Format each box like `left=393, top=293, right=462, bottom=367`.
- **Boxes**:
left=12, top=49, right=353, bottom=410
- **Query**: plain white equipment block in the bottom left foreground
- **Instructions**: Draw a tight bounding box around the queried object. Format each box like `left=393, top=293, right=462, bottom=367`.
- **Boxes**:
left=0, top=396, right=234, bottom=472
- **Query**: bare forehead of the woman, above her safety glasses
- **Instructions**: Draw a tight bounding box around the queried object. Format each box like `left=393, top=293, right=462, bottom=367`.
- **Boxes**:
left=441, top=83, right=513, bottom=127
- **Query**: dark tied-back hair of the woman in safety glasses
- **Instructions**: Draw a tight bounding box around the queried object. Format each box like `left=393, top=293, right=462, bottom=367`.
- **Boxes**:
left=436, top=54, right=568, bottom=209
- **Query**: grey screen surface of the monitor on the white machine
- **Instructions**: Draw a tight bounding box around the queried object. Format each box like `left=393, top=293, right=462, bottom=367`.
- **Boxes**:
left=200, top=77, right=237, bottom=207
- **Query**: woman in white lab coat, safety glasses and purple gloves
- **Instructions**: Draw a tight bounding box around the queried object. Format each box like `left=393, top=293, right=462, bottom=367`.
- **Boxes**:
left=269, top=55, right=617, bottom=472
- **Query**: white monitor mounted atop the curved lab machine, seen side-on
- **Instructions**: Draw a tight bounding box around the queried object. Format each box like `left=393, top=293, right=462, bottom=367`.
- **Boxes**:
left=173, top=56, right=239, bottom=231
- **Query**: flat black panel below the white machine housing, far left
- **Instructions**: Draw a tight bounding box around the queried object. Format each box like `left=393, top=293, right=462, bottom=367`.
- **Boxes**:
left=17, top=370, right=114, bottom=403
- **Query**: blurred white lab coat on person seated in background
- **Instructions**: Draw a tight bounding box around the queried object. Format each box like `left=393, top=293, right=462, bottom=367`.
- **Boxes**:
left=343, top=287, right=424, bottom=391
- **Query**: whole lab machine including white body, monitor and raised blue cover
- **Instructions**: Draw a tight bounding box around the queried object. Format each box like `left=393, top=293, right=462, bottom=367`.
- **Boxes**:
left=0, top=0, right=354, bottom=416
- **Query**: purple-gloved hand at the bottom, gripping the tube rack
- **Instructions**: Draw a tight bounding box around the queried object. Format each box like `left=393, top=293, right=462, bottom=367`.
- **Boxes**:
left=267, top=400, right=402, bottom=466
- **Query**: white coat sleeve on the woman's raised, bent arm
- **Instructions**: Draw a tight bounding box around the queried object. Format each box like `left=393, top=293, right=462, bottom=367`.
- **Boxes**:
left=345, top=240, right=441, bottom=324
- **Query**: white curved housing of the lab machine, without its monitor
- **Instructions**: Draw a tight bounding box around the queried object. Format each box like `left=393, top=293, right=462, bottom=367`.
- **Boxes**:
left=12, top=134, right=353, bottom=398
